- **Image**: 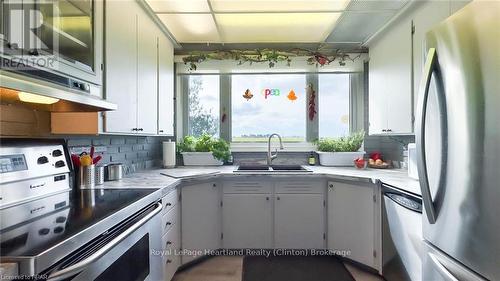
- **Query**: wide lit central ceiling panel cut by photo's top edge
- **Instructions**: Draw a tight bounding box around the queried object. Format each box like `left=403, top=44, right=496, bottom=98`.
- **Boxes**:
left=210, top=0, right=349, bottom=13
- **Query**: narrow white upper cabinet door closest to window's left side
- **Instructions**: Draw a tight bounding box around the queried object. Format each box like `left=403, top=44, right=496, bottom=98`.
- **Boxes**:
left=158, top=34, right=174, bottom=136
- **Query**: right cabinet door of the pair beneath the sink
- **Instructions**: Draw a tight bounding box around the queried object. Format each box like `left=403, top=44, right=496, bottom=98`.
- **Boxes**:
left=274, top=194, right=325, bottom=249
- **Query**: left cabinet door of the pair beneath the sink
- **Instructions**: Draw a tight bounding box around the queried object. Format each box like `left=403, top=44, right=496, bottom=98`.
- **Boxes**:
left=222, top=194, right=272, bottom=249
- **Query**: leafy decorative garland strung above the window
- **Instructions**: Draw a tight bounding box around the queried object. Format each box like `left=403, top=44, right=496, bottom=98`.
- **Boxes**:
left=182, top=48, right=361, bottom=71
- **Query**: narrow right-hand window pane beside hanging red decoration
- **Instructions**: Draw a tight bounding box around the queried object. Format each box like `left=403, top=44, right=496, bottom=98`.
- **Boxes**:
left=318, top=74, right=350, bottom=138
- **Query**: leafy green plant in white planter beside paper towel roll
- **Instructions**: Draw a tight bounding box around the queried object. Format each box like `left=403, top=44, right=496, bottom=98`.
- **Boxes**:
left=177, top=134, right=231, bottom=166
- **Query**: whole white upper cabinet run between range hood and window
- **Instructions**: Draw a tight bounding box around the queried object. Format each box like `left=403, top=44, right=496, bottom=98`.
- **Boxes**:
left=103, top=0, right=174, bottom=135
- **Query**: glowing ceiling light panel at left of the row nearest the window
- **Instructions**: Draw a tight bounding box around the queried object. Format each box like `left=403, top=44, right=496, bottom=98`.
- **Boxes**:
left=158, top=14, right=220, bottom=43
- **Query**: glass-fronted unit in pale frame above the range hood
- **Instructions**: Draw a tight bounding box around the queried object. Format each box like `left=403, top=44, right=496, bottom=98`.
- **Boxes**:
left=0, top=0, right=103, bottom=88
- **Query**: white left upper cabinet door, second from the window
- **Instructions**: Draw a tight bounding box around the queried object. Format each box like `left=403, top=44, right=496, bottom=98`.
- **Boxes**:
left=137, top=11, right=158, bottom=134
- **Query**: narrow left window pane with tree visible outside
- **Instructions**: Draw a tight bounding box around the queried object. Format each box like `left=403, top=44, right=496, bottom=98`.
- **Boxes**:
left=188, top=75, right=220, bottom=137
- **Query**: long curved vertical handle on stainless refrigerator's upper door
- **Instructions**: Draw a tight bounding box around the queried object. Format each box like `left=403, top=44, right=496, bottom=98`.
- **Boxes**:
left=415, top=48, right=437, bottom=224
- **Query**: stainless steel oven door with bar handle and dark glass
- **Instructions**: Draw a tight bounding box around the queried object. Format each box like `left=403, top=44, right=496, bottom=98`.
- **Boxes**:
left=41, top=202, right=163, bottom=281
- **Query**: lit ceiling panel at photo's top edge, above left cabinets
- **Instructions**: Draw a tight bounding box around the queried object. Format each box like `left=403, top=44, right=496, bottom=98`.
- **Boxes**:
left=146, top=0, right=210, bottom=13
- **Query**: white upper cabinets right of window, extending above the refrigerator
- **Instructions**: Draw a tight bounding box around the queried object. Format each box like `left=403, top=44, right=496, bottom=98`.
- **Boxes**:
left=368, top=0, right=469, bottom=135
